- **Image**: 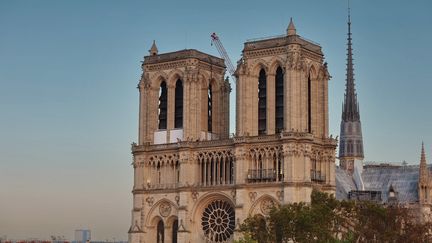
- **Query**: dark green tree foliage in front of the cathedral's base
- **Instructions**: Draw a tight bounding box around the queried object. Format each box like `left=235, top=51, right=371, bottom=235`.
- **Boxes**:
left=237, top=190, right=432, bottom=243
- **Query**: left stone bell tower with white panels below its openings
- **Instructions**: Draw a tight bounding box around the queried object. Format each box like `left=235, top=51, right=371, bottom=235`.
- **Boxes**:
left=138, top=42, right=231, bottom=145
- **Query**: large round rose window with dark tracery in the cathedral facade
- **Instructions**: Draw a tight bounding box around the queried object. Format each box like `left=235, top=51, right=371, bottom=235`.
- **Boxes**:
left=201, top=200, right=235, bottom=242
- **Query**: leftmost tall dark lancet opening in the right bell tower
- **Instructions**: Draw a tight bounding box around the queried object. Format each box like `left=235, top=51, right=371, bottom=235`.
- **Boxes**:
left=258, top=69, right=267, bottom=134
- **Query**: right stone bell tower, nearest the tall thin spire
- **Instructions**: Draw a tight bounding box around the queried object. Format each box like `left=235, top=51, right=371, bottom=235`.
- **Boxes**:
left=236, top=19, right=330, bottom=138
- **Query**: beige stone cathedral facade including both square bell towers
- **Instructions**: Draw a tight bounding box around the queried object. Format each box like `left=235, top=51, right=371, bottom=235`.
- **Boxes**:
left=129, top=22, right=337, bottom=243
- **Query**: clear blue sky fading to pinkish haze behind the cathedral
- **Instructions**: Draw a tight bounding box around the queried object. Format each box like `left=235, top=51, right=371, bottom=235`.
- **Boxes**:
left=0, top=0, right=432, bottom=240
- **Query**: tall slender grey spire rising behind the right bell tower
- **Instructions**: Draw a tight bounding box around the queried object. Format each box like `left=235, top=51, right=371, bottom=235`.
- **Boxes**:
left=339, top=9, right=364, bottom=173
